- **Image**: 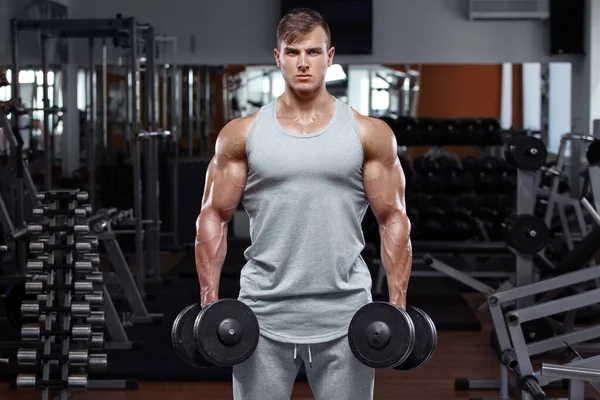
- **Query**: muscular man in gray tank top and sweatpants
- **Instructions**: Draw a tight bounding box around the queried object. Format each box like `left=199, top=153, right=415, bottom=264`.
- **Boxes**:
left=196, top=9, right=412, bottom=400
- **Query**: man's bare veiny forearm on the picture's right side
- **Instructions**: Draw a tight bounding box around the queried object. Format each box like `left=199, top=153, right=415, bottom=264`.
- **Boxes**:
left=379, top=212, right=412, bottom=308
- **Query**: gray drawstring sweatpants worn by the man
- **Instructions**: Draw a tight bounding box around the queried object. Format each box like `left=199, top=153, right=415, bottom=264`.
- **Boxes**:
left=233, top=335, right=375, bottom=400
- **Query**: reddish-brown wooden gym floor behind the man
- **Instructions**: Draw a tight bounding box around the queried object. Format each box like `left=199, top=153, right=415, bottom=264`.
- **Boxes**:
left=0, top=293, right=598, bottom=400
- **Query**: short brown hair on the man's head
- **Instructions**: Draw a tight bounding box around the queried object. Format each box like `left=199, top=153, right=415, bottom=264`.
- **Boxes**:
left=277, top=7, right=331, bottom=48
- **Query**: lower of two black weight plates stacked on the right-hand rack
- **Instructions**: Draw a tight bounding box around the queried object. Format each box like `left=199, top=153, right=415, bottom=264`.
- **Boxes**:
left=502, top=214, right=549, bottom=254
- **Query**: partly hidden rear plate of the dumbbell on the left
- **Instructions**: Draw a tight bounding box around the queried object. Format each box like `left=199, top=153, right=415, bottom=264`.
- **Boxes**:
left=171, top=303, right=211, bottom=367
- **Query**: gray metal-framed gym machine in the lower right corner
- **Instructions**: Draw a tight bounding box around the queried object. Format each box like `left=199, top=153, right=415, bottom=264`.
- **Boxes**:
left=456, top=139, right=600, bottom=399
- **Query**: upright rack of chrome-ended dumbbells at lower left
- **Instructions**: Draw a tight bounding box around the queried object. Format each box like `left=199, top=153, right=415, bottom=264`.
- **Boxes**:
left=16, top=190, right=107, bottom=400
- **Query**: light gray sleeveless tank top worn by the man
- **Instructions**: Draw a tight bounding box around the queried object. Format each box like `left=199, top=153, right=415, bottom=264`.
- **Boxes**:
left=239, top=99, right=372, bottom=344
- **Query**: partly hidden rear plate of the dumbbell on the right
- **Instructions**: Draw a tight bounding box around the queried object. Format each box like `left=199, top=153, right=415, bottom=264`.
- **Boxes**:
left=394, top=306, right=437, bottom=371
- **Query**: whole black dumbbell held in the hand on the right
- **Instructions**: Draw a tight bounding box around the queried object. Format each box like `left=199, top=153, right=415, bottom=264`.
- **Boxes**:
left=348, top=301, right=437, bottom=371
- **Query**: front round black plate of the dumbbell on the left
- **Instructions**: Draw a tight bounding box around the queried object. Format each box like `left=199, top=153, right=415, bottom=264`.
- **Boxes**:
left=194, top=299, right=260, bottom=367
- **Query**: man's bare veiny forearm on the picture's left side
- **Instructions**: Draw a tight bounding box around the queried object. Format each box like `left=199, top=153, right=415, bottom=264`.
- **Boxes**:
left=195, top=210, right=227, bottom=307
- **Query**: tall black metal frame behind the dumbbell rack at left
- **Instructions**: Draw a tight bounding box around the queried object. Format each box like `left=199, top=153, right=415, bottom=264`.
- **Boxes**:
left=11, top=17, right=169, bottom=298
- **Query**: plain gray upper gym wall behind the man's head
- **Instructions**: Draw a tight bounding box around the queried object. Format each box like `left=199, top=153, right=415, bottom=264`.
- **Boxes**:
left=30, top=0, right=564, bottom=64
